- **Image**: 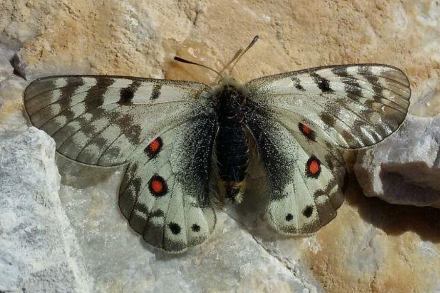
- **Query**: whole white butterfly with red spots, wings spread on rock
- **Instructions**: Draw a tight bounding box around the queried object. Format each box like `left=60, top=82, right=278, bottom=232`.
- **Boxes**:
left=24, top=37, right=411, bottom=252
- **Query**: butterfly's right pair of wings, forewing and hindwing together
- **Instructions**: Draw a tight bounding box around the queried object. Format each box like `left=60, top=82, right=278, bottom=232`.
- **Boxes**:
left=246, top=64, right=411, bottom=234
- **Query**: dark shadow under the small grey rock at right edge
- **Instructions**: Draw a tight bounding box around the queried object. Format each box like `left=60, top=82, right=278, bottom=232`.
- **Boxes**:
left=345, top=172, right=440, bottom=243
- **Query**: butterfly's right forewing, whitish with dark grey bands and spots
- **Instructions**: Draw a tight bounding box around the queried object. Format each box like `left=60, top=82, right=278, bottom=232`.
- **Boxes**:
left=246, top=64, right=411, bottom=148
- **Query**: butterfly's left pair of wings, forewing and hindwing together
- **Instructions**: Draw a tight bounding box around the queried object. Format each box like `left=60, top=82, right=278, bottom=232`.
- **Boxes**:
left=24, top=76, right=216, bottom=252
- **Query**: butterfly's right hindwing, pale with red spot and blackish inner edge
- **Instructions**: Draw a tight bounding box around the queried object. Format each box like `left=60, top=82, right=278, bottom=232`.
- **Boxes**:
left=248, top=113, right=343, bottom=234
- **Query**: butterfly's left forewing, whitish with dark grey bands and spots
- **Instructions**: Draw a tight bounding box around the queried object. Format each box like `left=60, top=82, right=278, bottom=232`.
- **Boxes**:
left=24, top=75, right=209, bottom=166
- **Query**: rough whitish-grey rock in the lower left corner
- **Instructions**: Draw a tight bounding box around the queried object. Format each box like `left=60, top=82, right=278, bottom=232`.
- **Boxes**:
left=0, top=127, right=88, bottom=292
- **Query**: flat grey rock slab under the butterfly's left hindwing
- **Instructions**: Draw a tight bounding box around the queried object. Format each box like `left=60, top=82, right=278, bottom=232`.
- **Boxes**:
left=58, top=156, right=320, bottom=292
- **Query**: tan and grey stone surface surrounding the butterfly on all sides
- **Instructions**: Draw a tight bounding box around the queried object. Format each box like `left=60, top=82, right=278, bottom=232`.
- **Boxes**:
left=0, top=0, right=440, bottom=292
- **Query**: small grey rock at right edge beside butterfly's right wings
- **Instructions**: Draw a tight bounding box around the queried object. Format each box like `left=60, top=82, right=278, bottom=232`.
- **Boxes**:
left=354, top=115, right=440, bottom=207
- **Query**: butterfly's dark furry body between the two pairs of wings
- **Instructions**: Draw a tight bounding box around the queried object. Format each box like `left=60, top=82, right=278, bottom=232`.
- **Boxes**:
left=212, top=81, right=249, bottom=202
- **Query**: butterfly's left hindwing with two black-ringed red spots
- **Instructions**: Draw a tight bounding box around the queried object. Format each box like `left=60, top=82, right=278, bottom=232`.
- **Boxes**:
left=119, top=117, right=216, bottom=252
